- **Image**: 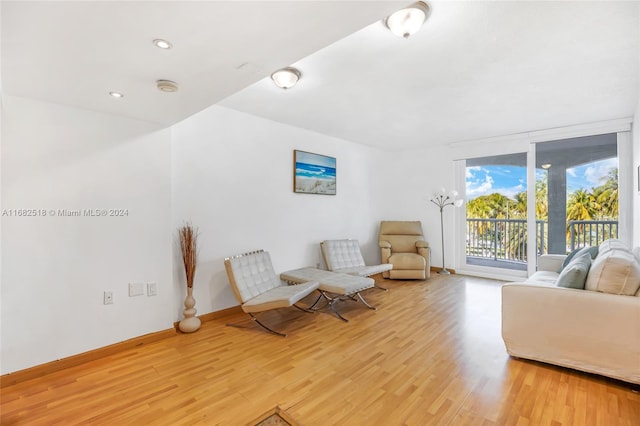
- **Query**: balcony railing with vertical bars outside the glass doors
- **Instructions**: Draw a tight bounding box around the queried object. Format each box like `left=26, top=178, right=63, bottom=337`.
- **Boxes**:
left=466, top=219, right=618, bottom=263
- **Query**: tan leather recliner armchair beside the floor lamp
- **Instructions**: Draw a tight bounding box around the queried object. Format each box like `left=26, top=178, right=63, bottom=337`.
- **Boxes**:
left=378, top=220, right=431, bottom=280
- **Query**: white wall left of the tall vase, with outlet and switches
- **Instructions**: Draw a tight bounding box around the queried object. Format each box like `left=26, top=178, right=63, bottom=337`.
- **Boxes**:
left=1, top=96, right=176, bottom=374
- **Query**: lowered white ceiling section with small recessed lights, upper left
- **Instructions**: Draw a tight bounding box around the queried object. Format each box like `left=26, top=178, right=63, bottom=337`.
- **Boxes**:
left=0, top=0, right=398, bottom=124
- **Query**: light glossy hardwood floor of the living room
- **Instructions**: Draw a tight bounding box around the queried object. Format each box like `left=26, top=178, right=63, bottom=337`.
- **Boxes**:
left=1, top=275, right=640, bottom=426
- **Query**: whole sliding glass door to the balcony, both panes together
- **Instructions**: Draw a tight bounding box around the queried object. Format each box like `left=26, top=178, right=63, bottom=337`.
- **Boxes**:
left=458, top=133, right=619, bottom=276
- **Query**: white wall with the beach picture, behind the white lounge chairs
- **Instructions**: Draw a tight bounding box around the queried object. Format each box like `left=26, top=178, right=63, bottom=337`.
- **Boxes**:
left=172, top=106, right=380, bottom=314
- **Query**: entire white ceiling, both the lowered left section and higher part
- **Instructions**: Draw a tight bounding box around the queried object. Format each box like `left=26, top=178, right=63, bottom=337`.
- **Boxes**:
left=2, top=0, right=640, bottom=150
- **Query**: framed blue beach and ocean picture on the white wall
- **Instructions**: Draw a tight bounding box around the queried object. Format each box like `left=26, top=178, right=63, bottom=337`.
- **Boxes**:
left=293, top=149, right=336, bottom=195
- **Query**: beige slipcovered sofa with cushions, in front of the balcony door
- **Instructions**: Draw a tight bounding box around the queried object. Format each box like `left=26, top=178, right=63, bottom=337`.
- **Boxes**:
left=502, top=240, right=640, bottom=384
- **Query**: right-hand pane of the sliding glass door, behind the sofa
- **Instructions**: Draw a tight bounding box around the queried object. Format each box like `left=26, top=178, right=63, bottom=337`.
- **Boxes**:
left=536, top=133, right=618, bottom=254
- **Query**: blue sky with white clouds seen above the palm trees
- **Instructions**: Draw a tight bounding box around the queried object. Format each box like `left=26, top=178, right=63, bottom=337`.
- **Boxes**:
left=466, top=158, right=618, bottom=200
